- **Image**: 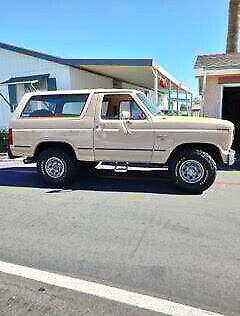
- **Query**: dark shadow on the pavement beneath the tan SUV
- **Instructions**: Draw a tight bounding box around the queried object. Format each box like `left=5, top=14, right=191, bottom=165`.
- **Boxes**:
left=0, top=167, right=200, bottom=195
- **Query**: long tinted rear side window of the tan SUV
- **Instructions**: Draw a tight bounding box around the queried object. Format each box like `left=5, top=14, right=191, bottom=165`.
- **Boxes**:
left=21, top=94, right=89, bottom=117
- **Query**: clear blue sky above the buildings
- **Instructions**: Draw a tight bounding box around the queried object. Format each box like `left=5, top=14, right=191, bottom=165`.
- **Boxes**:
left=0, top=0, right=227, bottom=95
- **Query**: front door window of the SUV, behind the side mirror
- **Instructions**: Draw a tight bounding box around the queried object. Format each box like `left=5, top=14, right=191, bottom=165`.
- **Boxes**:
left=101, top=94, right=146, bottom=120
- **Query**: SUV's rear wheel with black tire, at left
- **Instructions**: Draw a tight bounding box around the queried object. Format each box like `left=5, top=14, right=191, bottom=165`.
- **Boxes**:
left=37, top=148, right=78, bottom=186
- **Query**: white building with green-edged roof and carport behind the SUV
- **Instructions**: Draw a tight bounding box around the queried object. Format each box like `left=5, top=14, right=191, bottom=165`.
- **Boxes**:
left=0, top=43, right=191, bottom=129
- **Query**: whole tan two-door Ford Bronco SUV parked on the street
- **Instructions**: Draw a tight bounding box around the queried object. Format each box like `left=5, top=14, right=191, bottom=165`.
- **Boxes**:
left=9, top=89, right=234, bottom=192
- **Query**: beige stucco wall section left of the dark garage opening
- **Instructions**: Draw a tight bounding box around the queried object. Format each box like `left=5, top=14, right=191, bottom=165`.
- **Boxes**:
left=203, top=76, right=222, bottom=118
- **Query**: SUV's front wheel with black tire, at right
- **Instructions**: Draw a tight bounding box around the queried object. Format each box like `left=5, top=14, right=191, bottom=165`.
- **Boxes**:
left=168, top=149, right=217, bottom=193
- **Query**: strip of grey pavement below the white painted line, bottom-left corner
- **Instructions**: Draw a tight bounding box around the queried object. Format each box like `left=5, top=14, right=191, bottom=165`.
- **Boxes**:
left=0, top=273, right=166, bottom=316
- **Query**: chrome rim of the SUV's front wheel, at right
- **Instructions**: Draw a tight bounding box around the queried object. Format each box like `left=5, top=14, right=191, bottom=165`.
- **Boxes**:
left=179, top=160, right=204, bottom=184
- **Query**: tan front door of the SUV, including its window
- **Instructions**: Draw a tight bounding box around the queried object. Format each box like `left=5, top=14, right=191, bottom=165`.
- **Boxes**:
left=94, top=93, right=154, bottom=163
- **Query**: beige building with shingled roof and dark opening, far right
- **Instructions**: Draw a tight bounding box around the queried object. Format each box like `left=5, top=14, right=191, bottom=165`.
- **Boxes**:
left=194, top=53, right=240, bottom=147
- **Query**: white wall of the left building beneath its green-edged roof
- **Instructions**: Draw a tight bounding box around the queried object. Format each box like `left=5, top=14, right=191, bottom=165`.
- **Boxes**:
left=0, top=49, right=156, bottom=129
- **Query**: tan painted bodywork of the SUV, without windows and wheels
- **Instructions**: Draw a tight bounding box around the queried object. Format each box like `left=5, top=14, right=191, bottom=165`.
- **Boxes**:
left=10, top=87, right=234, bottom=164
